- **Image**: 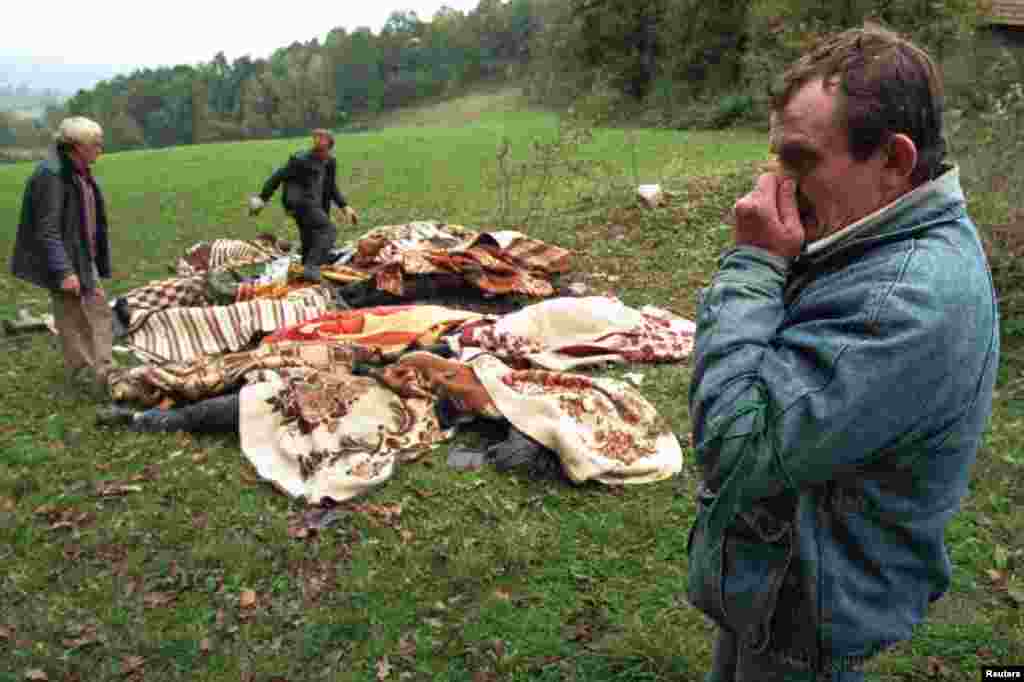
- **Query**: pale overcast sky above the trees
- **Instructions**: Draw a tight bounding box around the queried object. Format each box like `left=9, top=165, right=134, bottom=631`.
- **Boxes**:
left=0, top=0, right=478, bottom=70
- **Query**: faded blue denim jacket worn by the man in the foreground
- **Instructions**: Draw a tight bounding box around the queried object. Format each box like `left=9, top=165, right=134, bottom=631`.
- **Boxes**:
left=687, top=168, right=999, bottom=671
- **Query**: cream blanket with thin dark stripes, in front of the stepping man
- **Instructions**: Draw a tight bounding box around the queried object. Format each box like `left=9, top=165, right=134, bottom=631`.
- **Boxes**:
left=123, top=287, right=331, bottom=363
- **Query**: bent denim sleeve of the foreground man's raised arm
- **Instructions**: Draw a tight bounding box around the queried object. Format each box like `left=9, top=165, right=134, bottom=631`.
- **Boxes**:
left=690, top=247, right=956, bottom=512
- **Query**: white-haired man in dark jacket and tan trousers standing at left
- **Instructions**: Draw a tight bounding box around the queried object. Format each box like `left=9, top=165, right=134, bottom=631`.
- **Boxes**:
left=10, top=116, right=113, bottom=388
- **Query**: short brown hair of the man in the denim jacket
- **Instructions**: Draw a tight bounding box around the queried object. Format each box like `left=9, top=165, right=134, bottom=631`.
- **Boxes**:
left=771, top=24, right=946, bottom=185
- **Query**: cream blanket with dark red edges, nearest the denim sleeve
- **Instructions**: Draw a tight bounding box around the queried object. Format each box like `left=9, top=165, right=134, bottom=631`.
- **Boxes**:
left=449, top=296, right=696, bottom=370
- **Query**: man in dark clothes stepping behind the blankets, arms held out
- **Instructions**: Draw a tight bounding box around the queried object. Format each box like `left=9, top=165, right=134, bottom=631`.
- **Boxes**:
left=249, top=129, right=358, bottom=282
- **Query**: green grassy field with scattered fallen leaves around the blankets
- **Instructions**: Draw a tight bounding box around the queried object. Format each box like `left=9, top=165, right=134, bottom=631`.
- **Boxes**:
left=0, top=95, right=1024, bottom=682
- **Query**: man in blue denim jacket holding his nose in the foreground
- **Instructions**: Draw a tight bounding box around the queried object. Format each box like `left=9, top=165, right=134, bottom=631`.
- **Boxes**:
left=688, top=23, right=998, bottom=682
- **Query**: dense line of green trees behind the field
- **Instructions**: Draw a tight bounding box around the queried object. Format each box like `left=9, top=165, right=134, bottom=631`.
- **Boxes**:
left=0, top=0, right=1024, bottom=154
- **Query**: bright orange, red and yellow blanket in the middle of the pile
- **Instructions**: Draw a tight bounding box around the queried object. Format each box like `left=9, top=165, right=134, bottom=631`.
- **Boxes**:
left=263, top=305, right=481, bottom=354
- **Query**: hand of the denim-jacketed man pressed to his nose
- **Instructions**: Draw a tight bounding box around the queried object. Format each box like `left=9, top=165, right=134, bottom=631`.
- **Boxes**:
left=733, top=173, right=806, bottom=258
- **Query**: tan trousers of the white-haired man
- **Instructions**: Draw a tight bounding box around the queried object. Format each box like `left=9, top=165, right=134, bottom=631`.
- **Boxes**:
left=50, top=290, right=114, bottom=385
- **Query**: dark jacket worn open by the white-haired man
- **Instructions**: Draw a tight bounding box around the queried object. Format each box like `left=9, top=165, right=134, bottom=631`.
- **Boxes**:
left=10, top=150, right=111, bottom=291
